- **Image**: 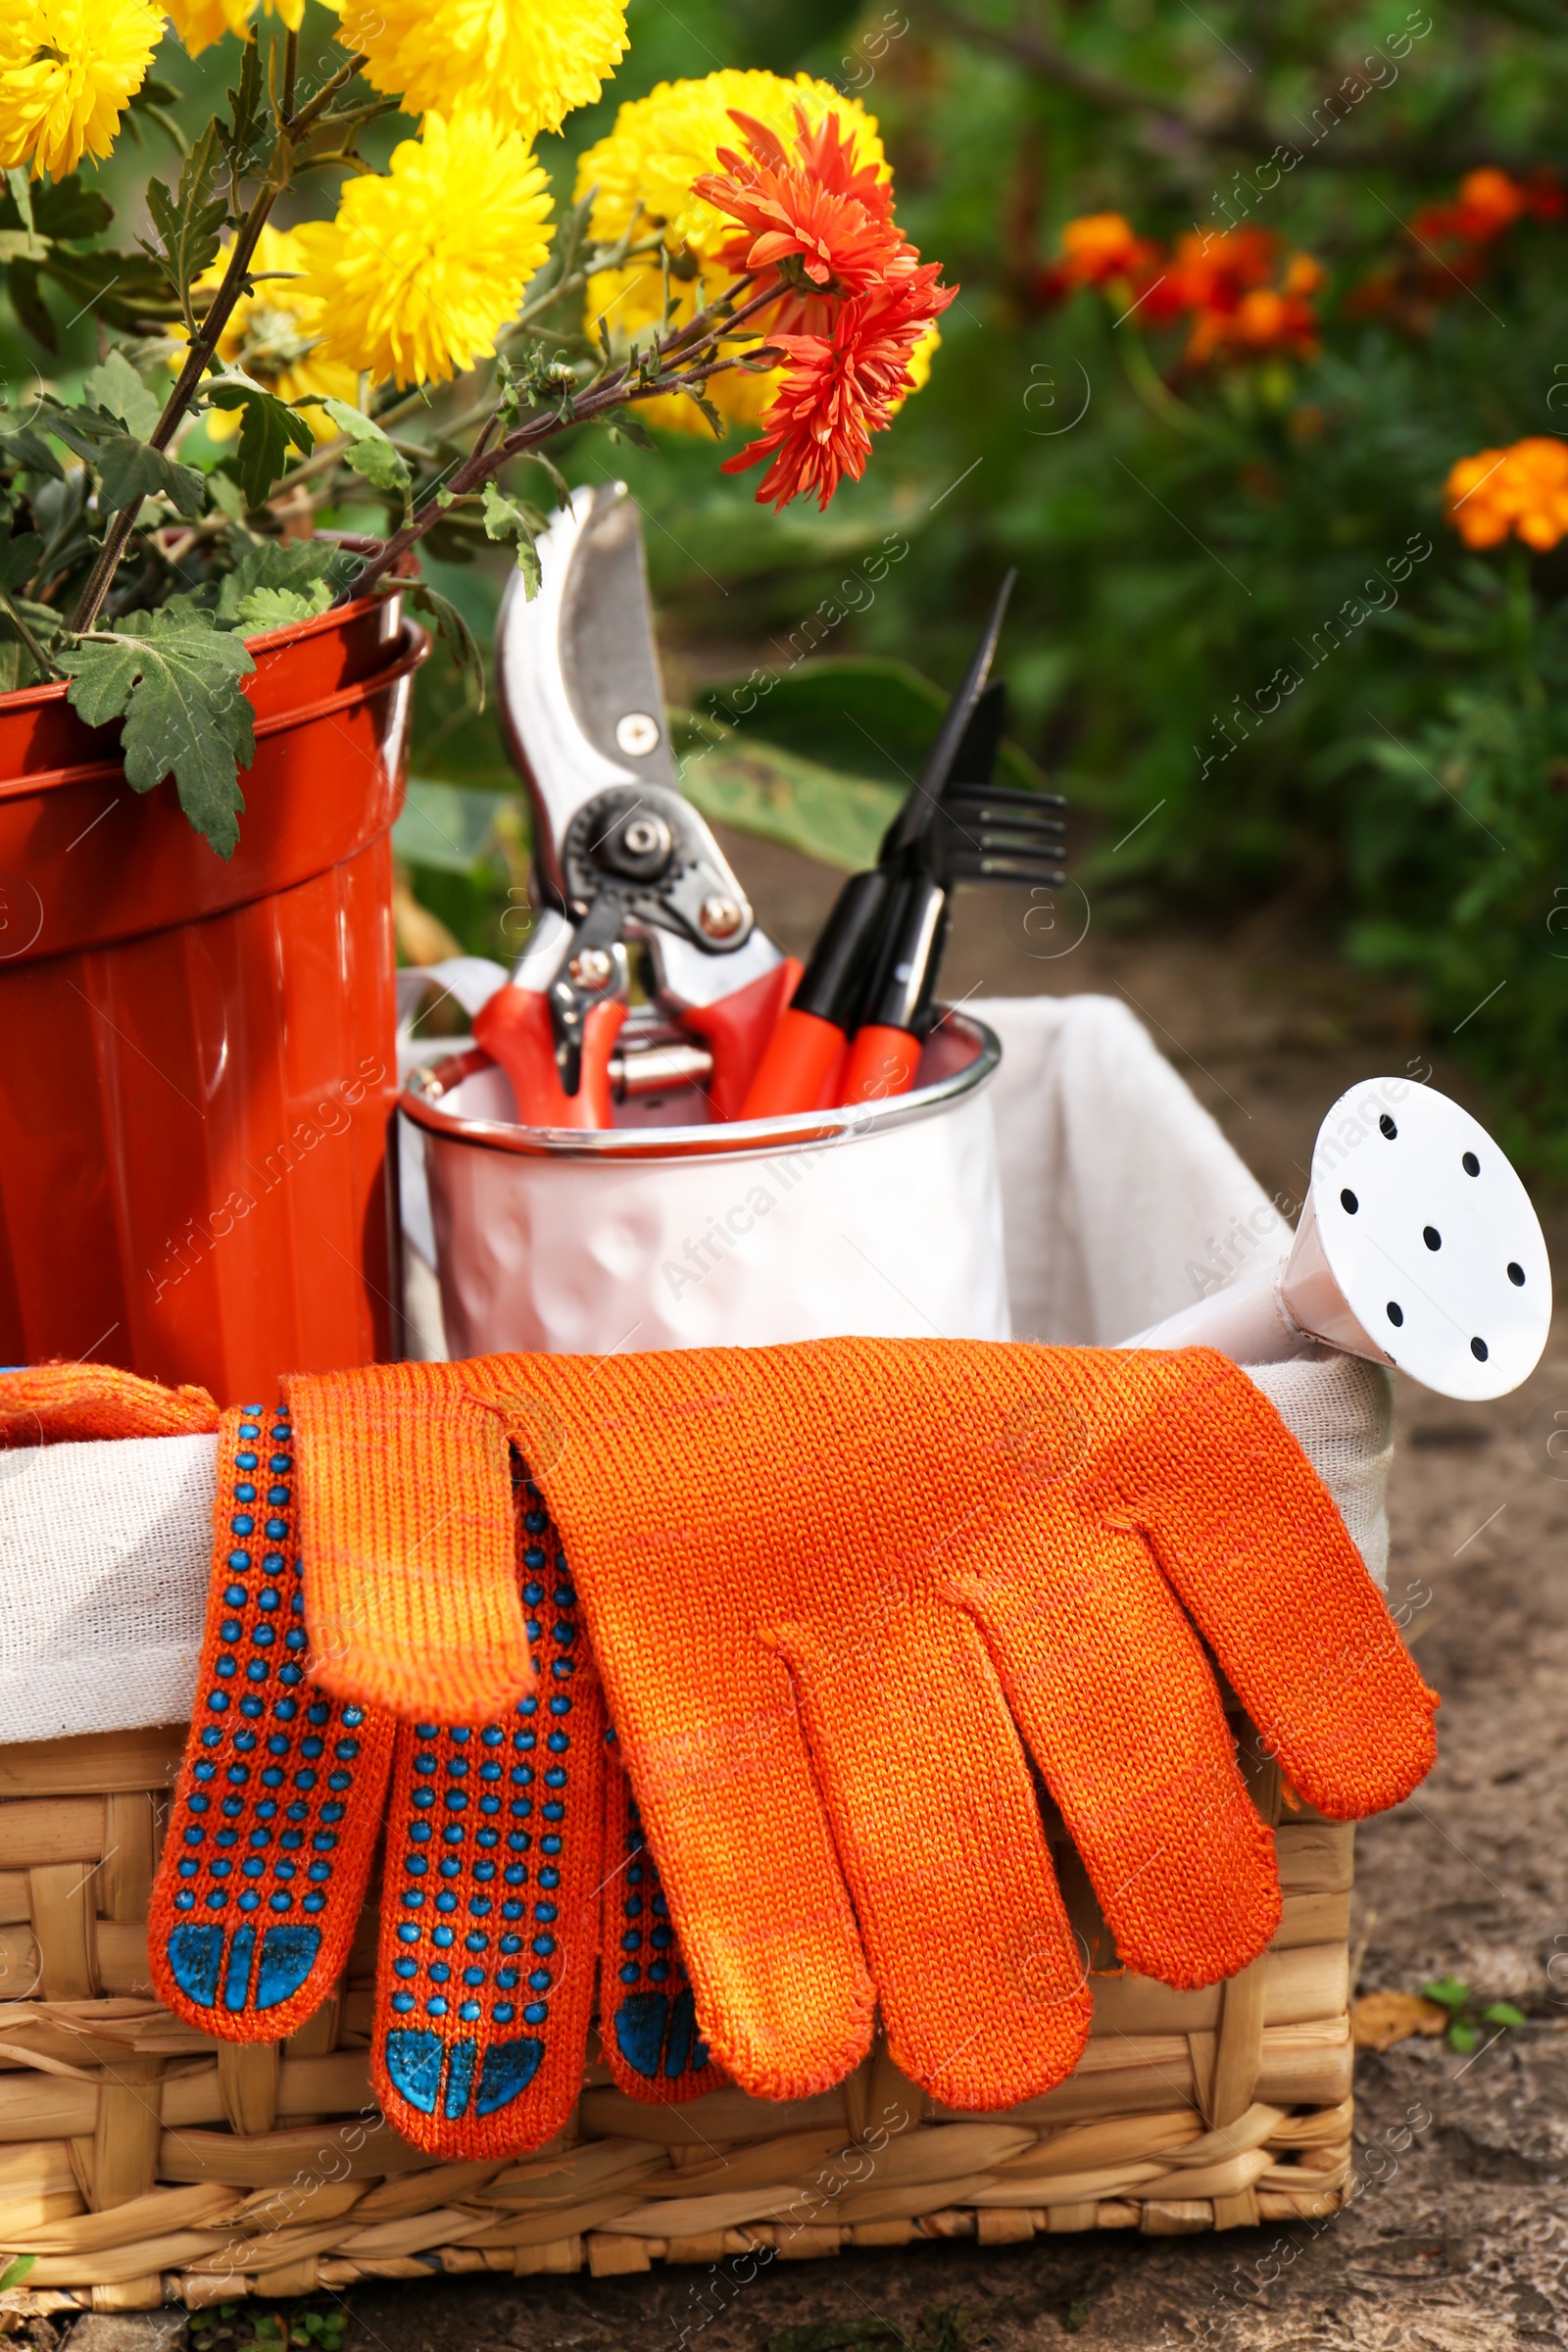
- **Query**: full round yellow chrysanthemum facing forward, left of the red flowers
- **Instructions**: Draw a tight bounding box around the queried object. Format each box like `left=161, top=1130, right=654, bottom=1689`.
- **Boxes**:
left=294, top=113, right=555, bottom=383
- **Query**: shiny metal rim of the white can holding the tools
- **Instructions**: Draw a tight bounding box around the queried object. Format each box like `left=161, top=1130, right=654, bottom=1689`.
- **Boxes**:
left=397, top=1009, right=1002, bottom=1166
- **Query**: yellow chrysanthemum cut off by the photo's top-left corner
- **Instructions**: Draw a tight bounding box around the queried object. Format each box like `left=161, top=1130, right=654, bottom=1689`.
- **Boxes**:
left=0, top=0, right=163, bottom=178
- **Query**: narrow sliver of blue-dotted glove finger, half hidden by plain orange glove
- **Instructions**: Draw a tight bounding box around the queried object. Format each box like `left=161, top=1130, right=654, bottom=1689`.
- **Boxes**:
left=600, top=1729, right=724, bottom=2105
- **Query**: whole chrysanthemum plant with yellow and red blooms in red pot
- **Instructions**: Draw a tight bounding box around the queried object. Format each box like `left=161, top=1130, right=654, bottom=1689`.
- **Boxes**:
left=0, top=0, right=950, bottom=1397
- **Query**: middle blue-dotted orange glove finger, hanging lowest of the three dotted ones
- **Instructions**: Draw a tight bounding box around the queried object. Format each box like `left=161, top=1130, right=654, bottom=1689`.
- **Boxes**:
left=371, top=1484, right=604, bottom=2159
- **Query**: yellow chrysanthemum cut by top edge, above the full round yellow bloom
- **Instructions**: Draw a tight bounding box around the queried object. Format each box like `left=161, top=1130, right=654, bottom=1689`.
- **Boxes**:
left=329, top=0, right=625, bottom=139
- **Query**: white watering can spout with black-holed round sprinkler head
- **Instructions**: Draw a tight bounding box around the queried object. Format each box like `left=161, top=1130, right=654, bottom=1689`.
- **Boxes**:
left=1121, top=1077, right=1551, bottom=1401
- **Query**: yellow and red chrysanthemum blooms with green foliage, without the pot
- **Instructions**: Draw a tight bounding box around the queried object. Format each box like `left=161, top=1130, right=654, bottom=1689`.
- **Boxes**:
left=0, top=0, right=953, bottom=857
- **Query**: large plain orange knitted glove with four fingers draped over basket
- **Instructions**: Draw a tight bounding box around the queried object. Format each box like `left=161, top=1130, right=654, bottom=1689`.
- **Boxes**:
left=463, top=1339, right=1437, bottom=2107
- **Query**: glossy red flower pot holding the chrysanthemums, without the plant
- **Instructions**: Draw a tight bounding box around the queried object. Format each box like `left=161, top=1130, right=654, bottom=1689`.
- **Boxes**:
left=0, top=598, right=428, bottom=1404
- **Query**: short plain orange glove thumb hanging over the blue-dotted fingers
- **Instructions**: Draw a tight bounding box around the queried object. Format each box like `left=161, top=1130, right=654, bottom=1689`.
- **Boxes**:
left=284, top=1364, right=534, bottom=1724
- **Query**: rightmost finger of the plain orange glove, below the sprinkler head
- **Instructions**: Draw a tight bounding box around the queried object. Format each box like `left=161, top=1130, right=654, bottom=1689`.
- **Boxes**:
left=1121, top=1350, right=1437, bottom=1821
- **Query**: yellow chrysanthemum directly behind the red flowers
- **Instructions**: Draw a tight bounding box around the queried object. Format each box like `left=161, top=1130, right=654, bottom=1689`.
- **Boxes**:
left=576, top=66, right=894, bottom=433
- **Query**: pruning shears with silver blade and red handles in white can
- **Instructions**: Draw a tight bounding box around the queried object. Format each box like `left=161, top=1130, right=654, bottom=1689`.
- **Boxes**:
left=475, top=482, right=783, bottom=1129
